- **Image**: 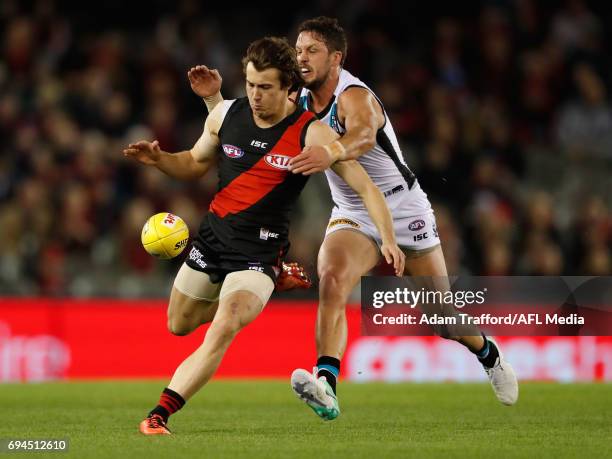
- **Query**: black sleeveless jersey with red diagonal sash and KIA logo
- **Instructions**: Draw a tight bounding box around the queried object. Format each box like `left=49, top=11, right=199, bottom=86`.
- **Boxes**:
left=203, top=97, right=316, bottom=264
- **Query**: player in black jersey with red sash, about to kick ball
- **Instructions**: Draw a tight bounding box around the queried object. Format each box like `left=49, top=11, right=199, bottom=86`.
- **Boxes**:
left=124, top=38, right=404, bottom=435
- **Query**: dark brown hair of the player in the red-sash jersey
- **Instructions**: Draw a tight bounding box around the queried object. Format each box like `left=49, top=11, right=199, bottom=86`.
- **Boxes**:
left=242, top=37, right=304, bottom=90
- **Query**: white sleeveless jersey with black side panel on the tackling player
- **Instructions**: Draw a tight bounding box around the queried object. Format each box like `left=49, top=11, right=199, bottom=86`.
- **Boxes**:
left=298, top=69, right=430, bottom=216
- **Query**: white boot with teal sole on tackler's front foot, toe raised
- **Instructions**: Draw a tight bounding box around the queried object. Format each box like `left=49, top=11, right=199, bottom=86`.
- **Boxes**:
left=291, top=367, right=340, bottom=421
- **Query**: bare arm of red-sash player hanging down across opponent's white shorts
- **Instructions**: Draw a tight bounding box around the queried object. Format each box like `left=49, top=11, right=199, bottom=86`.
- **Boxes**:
left=305, top=121, right=406, bottom=276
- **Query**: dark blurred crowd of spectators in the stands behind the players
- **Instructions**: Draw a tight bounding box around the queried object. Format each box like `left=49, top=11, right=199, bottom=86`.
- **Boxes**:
left=0, top=0, right=612, bottom=297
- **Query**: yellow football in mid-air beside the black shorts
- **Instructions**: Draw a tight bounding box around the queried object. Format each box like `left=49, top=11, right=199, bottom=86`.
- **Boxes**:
left=140, top=212, right=189, bottom=260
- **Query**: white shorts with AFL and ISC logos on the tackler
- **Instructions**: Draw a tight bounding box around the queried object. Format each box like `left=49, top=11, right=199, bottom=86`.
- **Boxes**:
left=325, top=182, right=440, bottom=251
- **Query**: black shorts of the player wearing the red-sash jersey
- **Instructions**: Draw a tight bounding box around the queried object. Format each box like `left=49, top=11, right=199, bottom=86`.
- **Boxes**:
left=185, top=224, right=280, bottom=284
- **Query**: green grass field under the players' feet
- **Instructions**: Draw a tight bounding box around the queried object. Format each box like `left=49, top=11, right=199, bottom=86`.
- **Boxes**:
left=0, top=381, right=612, bottom=459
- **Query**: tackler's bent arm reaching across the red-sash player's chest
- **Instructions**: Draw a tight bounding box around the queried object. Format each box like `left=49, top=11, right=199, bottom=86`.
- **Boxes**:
left=289, top=87, right=385, bottom=175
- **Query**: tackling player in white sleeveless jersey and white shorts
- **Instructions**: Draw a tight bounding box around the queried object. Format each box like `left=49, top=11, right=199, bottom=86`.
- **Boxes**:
left=190, top=17, right=518, bottom=420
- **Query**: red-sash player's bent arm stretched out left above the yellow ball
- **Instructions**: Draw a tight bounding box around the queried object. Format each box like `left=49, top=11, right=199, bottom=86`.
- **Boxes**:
left=123, top=106, right=221, bottom=180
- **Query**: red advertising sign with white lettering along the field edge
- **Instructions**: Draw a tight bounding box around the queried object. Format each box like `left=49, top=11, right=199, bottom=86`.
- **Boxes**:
left=0, top=298, right=612, bottom=381
